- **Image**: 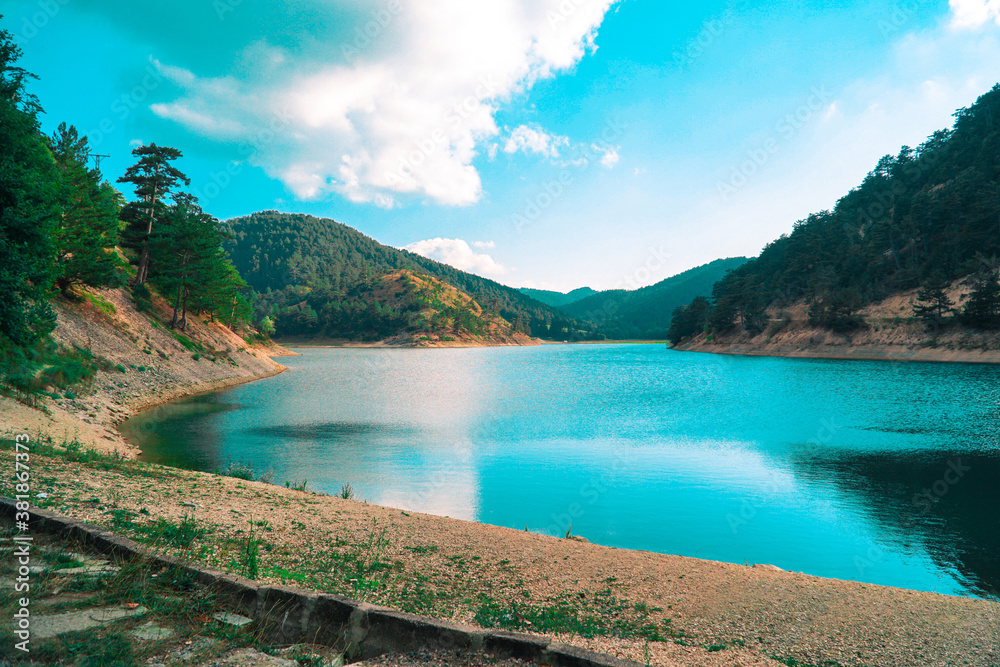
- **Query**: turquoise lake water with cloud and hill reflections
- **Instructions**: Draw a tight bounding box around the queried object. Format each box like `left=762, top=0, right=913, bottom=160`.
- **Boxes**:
left=125, top=345, right=1000, bottom=596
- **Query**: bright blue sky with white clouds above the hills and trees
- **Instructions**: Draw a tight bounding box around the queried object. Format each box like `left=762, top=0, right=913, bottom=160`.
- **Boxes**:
left=0, top=0, right=1000, bottom=290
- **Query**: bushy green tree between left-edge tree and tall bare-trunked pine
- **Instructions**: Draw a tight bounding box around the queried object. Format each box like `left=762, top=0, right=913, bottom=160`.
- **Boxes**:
left=49, top=123, right=124, bottom=294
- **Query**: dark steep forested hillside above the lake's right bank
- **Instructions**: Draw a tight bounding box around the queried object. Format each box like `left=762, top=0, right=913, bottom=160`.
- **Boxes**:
left=671, top=84, right=1000, bottom=341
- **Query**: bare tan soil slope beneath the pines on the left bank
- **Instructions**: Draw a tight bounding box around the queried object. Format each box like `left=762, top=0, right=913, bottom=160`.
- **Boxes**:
left=0, top=290, right=291, bottom=456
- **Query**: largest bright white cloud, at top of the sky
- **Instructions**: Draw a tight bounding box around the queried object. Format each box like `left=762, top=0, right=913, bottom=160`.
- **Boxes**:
left=153, top=0, right=619, bottom=206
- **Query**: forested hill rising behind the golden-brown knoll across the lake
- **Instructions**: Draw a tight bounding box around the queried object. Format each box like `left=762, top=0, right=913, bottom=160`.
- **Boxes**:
left=225, top=211, right=590, bottom=340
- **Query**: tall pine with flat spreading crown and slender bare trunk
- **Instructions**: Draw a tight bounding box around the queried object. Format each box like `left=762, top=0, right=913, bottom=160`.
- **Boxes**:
left=118, top=143, right=191, bottom=285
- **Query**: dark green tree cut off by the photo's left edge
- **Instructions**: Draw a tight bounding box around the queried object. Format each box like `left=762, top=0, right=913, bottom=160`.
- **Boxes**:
left=0, top=22, right=58, bottom=345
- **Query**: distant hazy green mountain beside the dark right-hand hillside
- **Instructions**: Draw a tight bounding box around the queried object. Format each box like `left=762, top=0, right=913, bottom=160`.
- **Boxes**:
left=562, top=257, right=748, bottom=340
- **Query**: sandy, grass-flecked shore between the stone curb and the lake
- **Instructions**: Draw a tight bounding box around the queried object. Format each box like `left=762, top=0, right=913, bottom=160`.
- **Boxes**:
left=17, top=448, right=1000, bottom=667
